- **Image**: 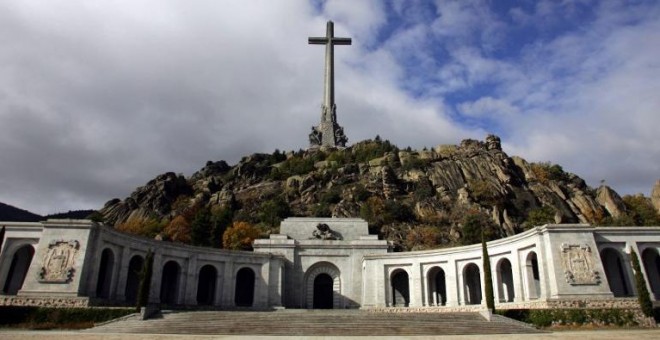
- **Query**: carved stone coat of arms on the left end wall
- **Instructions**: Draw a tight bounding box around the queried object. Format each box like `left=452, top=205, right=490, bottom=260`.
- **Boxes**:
left=39, top=240, right=80, bottom=283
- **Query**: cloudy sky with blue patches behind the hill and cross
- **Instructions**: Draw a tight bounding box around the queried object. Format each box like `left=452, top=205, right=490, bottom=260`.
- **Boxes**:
left=0, top=0, right=660, bottom=214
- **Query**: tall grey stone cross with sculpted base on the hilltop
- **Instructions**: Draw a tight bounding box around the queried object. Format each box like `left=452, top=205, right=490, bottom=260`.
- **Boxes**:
left=309, top=21, right=351, bottom=147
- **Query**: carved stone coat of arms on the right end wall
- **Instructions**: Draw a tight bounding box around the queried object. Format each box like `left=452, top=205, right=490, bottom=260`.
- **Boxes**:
left=561, top=243, right=600, bottom=285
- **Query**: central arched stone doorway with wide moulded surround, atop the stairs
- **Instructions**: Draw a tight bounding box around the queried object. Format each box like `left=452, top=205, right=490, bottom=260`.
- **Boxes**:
left=305, top=262, right=343, bottom=309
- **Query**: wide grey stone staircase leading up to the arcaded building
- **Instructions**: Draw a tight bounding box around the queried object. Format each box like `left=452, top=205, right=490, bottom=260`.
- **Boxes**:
left=86, top=309, right=540, bottom=336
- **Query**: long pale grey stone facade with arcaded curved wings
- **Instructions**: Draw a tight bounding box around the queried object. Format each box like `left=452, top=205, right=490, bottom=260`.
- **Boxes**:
left=0, top=218, right=660, bottom=311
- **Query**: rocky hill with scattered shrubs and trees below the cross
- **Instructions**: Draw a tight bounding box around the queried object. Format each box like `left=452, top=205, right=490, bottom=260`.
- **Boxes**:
left=100, top=135, right=648, bottom=250
